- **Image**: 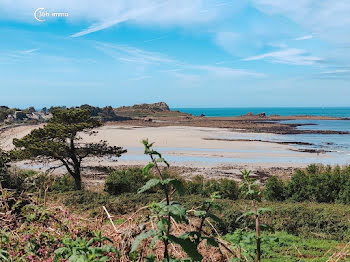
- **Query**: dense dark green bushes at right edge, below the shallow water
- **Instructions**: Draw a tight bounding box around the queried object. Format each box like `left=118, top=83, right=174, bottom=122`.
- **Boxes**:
left=264, top=164, right=350, bottom=204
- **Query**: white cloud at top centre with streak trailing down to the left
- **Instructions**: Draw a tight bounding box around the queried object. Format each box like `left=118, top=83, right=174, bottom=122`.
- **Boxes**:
left=67, top=0, right=228, bottom=37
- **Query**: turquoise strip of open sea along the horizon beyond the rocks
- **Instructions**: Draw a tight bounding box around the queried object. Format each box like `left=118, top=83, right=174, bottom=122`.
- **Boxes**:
left=172, top=107, right=350, bottom=117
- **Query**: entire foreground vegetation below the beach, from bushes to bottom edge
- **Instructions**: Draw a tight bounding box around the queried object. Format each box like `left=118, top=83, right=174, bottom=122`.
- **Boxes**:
left=0, top=134, right=350, bottom=262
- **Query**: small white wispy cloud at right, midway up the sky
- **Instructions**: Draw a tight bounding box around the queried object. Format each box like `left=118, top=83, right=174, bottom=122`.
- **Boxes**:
left=243, top=48, right=323, bottom=65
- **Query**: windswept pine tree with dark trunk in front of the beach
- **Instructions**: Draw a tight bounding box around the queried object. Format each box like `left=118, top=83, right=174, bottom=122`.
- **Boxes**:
left=13, top=108, right=126, bottom=190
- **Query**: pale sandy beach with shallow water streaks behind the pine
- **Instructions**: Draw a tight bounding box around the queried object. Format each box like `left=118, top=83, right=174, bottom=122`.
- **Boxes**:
left=0, top=124, right=348, bottom=182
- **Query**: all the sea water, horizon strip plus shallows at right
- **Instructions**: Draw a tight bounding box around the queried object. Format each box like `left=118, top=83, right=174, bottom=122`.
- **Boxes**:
left=172, top=107, right=350, bottom=164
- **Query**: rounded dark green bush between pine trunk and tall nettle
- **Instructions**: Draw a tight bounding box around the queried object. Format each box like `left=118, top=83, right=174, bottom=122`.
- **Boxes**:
left=105, top=167, right=150, bottom=195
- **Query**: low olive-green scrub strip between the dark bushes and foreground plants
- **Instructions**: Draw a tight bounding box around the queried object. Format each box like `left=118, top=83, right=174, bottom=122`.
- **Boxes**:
left=49, top=191, right=350, bottom=242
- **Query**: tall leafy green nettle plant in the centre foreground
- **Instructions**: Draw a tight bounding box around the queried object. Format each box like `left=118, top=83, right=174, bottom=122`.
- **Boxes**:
left=131, top=140, right=220, bottom=261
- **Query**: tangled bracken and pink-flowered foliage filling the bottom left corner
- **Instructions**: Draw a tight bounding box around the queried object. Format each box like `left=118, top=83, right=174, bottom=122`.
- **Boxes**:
left=0, top=186, right=119, bottom=262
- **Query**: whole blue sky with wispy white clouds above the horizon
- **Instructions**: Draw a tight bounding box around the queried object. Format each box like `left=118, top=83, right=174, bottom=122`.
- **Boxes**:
left=0, top=0, right=350, bottom=108
